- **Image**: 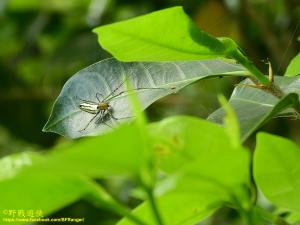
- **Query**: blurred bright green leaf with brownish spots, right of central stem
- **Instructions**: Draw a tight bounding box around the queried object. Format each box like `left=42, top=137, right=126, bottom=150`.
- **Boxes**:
left=151, top=116, right=249, bottom=198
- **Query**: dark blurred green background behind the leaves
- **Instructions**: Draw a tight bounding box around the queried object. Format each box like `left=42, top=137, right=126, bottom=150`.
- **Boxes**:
left=0, top=0, right=300, bottom=225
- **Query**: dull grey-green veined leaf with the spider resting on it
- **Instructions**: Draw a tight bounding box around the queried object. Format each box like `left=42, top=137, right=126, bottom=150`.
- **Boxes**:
left=43, top=59, right=245, bottom=138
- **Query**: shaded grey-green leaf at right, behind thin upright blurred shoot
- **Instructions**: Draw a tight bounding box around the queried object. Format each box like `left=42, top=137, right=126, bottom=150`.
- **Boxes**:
left=208, top=77, right=300, bottom=141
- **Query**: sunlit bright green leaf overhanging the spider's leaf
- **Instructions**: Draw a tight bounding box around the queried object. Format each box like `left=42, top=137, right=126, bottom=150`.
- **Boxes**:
left=94, top=7, right=237, bottom=61
